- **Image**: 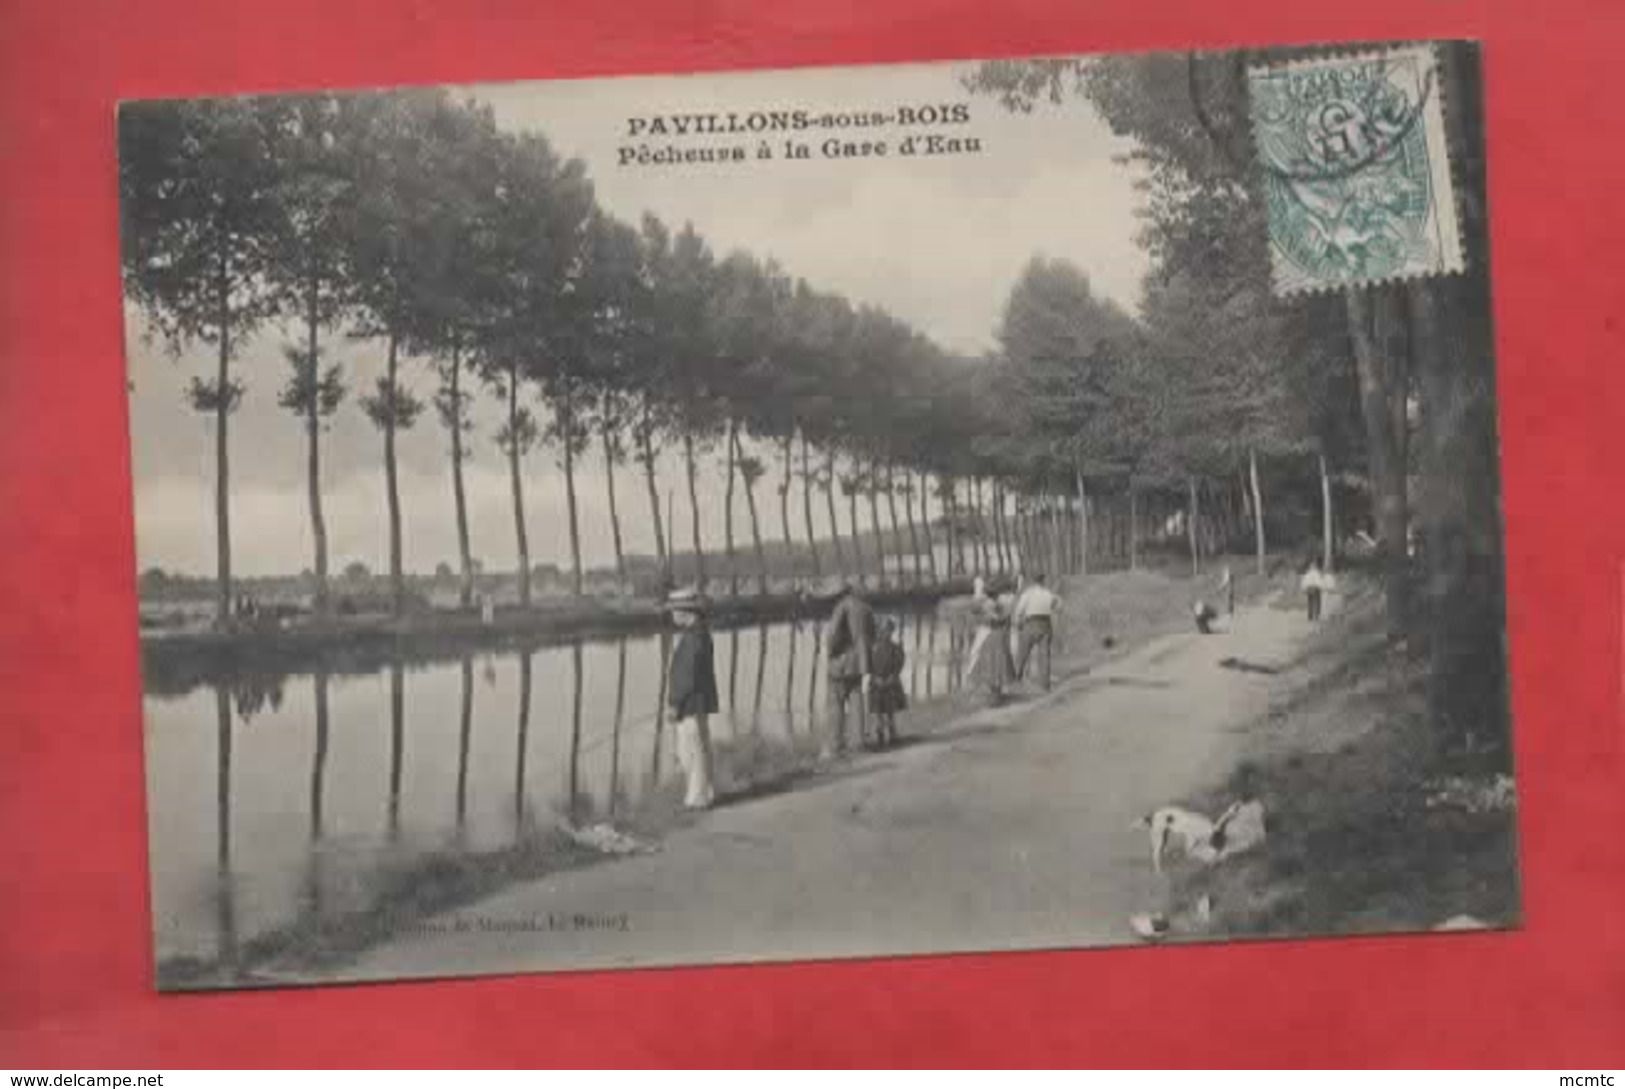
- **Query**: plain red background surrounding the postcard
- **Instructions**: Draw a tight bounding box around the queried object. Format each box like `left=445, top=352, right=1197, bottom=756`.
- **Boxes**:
left=0, top=0, right=1625, bottom=1069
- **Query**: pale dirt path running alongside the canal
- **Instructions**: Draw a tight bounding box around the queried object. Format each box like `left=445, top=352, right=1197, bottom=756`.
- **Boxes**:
left=299, top=591, right=1308, bottom=978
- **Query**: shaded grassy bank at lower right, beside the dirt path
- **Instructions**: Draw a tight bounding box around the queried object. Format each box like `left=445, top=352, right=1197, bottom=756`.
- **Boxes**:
left=1173, top=575, right=1521, bottom=938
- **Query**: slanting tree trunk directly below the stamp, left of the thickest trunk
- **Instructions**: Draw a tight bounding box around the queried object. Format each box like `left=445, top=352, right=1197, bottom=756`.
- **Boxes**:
left=1346, top=286, right=1411, bottom=640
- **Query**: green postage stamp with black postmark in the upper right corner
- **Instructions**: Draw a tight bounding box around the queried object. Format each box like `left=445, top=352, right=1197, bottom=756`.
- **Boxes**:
left=1248, top=46, right=1463, bottom=294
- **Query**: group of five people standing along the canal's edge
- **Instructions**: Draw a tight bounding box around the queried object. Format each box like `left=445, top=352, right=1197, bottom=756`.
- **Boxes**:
left=666, top=574, right=1061, bottom=809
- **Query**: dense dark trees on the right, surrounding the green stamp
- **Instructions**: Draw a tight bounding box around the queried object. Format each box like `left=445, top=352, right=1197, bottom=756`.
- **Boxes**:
left=967, top=44, right=1506, bottom=750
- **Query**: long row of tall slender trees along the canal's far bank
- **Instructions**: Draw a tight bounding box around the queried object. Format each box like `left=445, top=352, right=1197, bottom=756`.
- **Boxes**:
left=119, top=89, right=1076, bottom=618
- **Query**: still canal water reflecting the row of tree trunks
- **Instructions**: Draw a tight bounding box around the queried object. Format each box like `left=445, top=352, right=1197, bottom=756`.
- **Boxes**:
left=145, top=611, right=967, bottom=964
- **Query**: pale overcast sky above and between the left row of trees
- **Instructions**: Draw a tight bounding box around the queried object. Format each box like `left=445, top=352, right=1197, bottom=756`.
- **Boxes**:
left=128, top=57, right=1149, bottom=574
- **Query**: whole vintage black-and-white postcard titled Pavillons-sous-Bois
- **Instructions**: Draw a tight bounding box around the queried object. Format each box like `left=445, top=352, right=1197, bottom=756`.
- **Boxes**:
left=119, top=42, right=1519, bottom=990
